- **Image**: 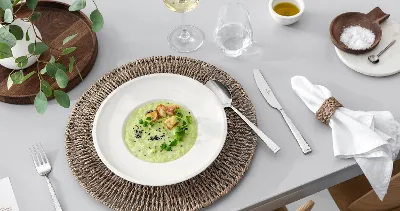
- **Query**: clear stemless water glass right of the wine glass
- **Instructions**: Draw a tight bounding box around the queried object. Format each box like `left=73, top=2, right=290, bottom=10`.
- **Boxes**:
left=214, top=3, right=253, bottom=57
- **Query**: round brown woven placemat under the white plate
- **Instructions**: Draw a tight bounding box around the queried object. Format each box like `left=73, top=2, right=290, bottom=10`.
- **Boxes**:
left=66, top=56, right=257, bottom=211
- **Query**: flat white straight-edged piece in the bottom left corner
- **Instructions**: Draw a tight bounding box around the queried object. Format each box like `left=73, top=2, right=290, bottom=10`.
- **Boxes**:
left=0, top=177, right=19, bottom=211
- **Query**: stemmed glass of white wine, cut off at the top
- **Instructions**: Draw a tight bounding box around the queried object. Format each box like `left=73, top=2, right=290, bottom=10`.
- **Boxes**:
left=163, top=0, right=204, bottom=53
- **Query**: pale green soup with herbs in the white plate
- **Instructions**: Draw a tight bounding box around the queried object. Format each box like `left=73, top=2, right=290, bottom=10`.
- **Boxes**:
left=124, top=101, right=197, bottom=163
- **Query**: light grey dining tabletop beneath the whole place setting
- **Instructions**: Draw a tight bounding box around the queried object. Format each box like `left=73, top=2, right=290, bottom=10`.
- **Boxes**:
left=0, top=0, right=400, bottom=211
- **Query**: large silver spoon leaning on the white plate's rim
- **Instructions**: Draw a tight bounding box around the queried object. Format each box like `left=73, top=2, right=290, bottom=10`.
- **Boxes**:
left=206, top=80, right=280, bottom=153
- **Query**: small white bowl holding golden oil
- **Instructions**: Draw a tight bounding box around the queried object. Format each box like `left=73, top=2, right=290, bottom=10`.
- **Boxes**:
left=268, top=0, right=305, bottom=26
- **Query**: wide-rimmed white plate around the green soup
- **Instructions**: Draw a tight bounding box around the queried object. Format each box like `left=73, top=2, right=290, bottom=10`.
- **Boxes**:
left=92, top=74, right=227, bottom=186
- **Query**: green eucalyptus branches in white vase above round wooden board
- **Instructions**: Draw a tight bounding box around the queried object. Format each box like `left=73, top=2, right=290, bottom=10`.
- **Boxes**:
left=0, top=0, right=104, bottom=114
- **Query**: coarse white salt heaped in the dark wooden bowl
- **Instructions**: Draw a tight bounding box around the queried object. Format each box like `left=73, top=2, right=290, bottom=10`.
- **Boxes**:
left=340, top=26, right=375, bottom=50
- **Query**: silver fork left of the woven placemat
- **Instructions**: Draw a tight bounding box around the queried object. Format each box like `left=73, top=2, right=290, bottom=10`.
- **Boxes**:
left=29, top=143, right=62, bottom=211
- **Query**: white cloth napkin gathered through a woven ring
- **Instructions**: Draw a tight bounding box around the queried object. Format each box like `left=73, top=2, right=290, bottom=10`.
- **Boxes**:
left=292, top=76, right=400, bottom=200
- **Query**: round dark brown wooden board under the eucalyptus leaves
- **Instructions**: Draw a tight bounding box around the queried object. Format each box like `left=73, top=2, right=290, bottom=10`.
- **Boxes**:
left=0, top=1, right=98, bottom=104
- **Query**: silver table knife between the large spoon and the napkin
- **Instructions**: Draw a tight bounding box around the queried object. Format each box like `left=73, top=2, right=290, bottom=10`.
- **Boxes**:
left=253, top=69, right=312, bottom=154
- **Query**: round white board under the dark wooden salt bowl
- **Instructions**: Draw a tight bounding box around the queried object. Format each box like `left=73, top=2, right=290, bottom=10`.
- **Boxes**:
left=335, top=19, right=400, bottom=77
